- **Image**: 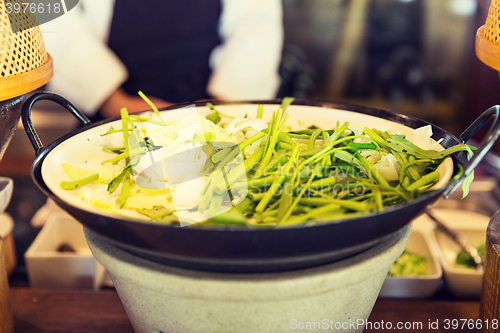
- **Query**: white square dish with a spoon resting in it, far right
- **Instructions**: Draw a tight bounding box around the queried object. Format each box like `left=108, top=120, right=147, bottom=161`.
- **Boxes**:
left=432, top=209, right=490, bottom=299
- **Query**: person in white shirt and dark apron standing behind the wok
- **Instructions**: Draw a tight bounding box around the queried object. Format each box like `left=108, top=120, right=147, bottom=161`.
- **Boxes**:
left=40, top=0, right=283, bottom=118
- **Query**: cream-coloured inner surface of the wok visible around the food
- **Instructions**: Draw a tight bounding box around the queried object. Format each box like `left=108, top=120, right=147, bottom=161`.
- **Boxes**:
left=42, top=104, right=453, bottom=221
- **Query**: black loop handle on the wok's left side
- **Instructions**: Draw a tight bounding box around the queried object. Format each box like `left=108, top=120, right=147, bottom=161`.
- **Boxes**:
left=21, top=92, right=90, bottom=156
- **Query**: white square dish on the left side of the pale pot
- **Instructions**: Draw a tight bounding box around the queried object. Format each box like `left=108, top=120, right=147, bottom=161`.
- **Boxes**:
left=24, top=214, right=105, bottom=290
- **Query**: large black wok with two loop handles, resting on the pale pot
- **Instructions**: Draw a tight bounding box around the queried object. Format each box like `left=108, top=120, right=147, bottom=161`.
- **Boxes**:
left=22, top=93, right=500, bottom=272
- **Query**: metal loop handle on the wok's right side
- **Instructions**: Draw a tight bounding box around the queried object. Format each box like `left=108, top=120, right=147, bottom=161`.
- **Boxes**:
left=443, top=105, right=500, bottom=199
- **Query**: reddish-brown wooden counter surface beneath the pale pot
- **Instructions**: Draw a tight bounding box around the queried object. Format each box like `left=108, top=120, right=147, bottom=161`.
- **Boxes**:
left=10, top=287, right=479, bottom=333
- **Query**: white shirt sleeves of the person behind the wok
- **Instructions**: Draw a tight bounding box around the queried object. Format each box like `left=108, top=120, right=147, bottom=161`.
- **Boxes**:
left=40, top=0, right=283, bottom=115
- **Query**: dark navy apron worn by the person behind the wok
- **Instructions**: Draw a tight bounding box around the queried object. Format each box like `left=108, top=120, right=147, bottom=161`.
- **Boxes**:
left=109, top=0, right=221, bottom=103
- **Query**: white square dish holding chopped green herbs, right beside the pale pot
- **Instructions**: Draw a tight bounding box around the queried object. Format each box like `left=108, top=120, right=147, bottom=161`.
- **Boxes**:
left=380, top=224, right=443, bottom=298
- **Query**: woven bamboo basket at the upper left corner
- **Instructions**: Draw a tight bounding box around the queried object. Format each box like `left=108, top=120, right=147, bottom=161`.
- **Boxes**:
left=0, top=0, right=52, bottom=101
